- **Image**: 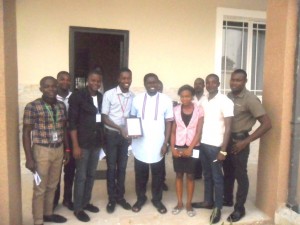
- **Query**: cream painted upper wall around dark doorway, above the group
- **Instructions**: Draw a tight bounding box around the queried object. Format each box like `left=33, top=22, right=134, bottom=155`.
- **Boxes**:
left=17, top=0, right=266, bottom=88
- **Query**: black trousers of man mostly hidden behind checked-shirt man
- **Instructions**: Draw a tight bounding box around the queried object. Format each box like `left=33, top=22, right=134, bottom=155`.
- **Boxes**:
left=53, top=153, right=76, bottom=205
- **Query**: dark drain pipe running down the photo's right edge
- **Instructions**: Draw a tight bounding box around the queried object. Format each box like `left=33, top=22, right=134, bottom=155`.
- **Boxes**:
left=287, top=0, right=300, bottom=213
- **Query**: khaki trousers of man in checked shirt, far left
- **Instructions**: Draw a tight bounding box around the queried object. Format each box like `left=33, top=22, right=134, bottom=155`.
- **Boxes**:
left=32, top=144, right=64, bottom=224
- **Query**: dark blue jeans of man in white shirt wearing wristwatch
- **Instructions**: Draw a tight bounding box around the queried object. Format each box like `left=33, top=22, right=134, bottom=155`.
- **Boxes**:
left=200, top=143, right=224, bottom=209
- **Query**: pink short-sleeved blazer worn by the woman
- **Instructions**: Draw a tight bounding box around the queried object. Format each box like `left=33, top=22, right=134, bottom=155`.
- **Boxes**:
left=174, top=105, right=204, bottom=146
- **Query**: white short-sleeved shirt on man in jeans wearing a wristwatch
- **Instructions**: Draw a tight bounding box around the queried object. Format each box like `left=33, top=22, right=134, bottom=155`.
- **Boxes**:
left=201, top=93, right=233, bottom=147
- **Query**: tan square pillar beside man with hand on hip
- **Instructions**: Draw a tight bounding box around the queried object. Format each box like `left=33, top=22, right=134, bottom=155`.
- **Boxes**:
left=256, top=0, right=297, bottom=217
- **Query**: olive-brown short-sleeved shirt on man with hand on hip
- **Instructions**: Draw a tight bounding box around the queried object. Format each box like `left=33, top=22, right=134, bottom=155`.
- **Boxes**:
left=228, top=88, right=266, bottom=133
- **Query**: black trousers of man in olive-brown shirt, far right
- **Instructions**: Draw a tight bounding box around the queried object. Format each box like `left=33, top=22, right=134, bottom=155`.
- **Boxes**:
left=223, top=138, right=250, bottom=211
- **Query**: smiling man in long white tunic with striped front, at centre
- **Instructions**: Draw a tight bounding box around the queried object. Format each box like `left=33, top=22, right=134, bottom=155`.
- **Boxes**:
left=131, top=73, right=173, bottom=214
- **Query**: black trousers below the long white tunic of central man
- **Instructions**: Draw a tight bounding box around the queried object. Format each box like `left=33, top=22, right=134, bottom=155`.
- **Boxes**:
left=134, top=158, right=164, bottom=202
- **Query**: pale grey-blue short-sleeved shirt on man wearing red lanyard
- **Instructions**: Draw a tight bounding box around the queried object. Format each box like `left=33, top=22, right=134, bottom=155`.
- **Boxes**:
left=101, top=86, right=134, bottom=130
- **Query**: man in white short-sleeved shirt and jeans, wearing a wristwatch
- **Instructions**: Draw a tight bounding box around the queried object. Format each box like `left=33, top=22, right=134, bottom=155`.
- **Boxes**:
left=192, top=74, right=233, bottom=224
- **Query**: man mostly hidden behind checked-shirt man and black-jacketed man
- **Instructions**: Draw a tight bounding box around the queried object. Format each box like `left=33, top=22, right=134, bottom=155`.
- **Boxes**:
left=53, top=71, right=76, bottom=210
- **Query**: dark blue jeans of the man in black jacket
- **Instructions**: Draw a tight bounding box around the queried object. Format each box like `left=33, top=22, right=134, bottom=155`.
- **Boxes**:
left=74, top=148, right=100, bottom=212
